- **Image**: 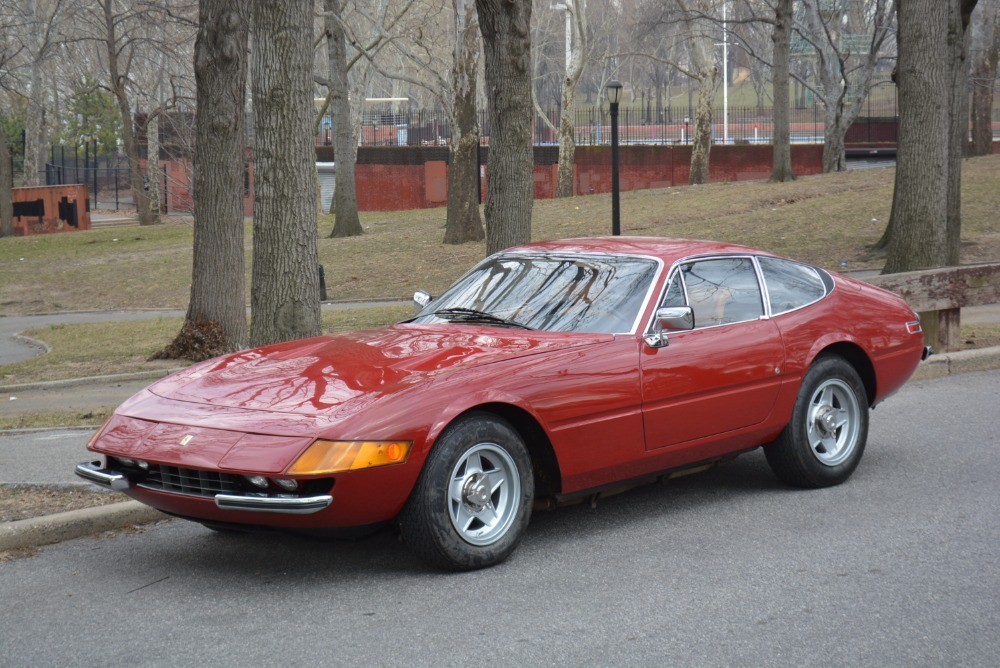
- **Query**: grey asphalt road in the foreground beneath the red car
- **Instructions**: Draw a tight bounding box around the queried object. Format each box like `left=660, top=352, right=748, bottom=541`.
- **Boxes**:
left=0, top=372, right=1000, bottom=667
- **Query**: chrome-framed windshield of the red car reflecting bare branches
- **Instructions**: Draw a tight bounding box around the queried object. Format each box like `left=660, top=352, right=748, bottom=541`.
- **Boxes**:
left=412, top=254, right=657, bottom=334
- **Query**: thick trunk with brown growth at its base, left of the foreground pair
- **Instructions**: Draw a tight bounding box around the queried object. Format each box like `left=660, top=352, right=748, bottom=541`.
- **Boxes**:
left=164, top=0, right=249, bottom=358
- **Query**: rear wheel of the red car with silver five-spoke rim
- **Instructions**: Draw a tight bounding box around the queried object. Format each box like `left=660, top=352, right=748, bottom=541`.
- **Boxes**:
left=764, top=356, right=868, bottom=487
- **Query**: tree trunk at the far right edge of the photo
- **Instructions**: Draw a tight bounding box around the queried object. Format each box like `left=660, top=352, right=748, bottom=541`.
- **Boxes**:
left=969, top=0, right=1000, bottom=155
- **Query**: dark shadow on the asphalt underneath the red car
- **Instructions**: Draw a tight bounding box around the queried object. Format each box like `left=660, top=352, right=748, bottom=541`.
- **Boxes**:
left=125, top=451, right=808, bottom=583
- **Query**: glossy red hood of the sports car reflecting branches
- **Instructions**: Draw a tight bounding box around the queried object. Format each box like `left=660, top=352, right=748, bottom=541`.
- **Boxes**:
left=149, top=324, right=613, bottom=415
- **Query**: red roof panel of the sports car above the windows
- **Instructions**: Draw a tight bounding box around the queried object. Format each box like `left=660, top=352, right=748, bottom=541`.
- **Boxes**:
left=504, top=236, right=771, bottom=265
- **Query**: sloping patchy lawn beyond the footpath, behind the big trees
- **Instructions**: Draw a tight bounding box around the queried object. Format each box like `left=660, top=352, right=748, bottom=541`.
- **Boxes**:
left=0, top=156, right=1000, bottom=315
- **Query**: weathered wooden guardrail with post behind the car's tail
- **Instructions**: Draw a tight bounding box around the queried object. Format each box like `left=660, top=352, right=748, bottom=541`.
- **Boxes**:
left=865, top=263, right=1000, bottom=352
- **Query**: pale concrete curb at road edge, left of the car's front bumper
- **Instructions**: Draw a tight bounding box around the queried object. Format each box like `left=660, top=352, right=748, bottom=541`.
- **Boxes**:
left=0, top=501, right=169, bottom=551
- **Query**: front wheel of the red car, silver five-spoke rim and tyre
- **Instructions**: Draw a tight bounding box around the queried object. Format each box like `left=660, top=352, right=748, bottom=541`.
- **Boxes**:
left=400, top=413, right=535, bottom=570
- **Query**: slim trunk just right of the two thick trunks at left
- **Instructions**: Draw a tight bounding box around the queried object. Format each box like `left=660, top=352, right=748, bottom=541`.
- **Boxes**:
left=326, top=0, right=364, bottom=237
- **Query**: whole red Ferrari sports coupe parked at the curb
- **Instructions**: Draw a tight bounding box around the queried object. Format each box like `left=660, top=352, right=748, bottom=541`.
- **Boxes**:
left=76, top=237, right=929, bottom=569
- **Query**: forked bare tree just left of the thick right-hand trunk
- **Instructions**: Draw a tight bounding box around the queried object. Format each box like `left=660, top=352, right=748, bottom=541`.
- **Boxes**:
left=796, top=0, right=896, bottom=172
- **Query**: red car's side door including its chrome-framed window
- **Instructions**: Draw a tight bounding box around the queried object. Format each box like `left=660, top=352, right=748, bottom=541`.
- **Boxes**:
left=640, top=256, right=784, bottom=450
